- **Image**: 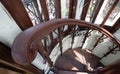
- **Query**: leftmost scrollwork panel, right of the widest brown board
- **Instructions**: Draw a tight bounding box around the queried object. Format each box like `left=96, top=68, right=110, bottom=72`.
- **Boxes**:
left=22, top=0, right=43, bottom=25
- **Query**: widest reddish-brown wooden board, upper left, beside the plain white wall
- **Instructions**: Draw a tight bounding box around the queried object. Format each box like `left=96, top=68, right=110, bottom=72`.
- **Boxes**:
left=0, top=0, right=33, bottom=30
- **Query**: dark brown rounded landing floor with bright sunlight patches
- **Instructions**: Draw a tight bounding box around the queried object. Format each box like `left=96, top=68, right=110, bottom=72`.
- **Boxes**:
left=55, top=48, right=103, bottom=74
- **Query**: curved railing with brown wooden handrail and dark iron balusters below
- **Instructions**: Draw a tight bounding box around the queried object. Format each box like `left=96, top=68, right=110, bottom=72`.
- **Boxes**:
left=12, top=19, right=120, bottom=73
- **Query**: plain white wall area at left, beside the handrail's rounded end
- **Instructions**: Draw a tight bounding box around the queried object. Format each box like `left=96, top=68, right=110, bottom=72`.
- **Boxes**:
left=0, top=3, right=21, bottom=47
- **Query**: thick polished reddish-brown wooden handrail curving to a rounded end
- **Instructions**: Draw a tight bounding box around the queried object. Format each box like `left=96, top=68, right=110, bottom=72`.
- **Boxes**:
left=12, top=19, right=120, bottom=65
